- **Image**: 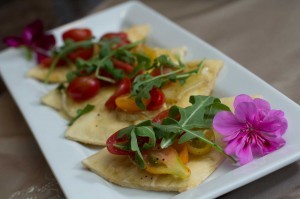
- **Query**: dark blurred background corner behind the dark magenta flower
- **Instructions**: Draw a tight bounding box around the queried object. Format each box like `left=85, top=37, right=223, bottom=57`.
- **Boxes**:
left=0, top=0, right=103, bottom=49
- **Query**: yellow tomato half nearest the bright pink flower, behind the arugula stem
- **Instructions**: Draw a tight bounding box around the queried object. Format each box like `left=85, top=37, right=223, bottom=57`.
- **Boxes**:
left=187, top=130, right=215, bottom=155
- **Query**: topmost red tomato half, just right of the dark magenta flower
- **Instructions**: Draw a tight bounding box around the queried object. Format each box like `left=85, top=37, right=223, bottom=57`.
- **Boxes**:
left=62, top=28, right=93, bottom=42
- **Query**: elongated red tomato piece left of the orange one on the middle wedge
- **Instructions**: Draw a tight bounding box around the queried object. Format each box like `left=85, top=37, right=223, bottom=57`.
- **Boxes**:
left=105, top=77, right=131, bottom=110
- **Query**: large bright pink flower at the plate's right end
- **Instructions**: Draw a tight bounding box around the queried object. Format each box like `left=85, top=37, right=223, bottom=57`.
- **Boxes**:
left=213, top=94, right=288, bottom=165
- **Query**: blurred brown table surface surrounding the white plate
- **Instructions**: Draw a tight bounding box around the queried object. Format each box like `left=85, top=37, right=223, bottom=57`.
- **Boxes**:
left=0, top=0, right=300, bottom=199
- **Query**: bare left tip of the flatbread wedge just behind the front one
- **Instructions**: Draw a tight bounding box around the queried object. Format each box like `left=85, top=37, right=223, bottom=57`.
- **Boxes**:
left=65, top=88, right=131, bottom=145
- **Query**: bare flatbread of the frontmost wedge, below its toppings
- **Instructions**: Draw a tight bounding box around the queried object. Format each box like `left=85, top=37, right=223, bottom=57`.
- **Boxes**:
left=82, top=148, right=224, bottom=192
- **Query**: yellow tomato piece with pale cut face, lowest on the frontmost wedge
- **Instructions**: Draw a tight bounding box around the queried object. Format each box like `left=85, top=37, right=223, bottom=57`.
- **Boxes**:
left=143, top=147, right=191, bottom=179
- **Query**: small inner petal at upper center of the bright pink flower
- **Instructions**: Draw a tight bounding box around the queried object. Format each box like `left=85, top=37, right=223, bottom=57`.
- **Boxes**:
left=235, top=102, right=257, bottom=124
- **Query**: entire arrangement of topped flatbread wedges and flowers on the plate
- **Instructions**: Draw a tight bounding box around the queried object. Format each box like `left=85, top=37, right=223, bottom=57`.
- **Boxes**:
left=4, top=21, right=288, bottom=192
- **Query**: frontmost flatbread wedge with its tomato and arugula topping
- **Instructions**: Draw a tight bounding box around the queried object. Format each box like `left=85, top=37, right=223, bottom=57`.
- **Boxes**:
left=83, top=96, right=230, bottom=192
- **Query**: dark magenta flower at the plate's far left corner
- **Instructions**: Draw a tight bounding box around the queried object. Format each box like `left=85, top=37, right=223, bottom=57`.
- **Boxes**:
left=3, top=20, right=55, bottom=63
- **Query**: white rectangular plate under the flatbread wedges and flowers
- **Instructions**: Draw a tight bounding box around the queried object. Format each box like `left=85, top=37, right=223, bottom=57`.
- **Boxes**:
left=0, top=2, right=300, bottom=199
